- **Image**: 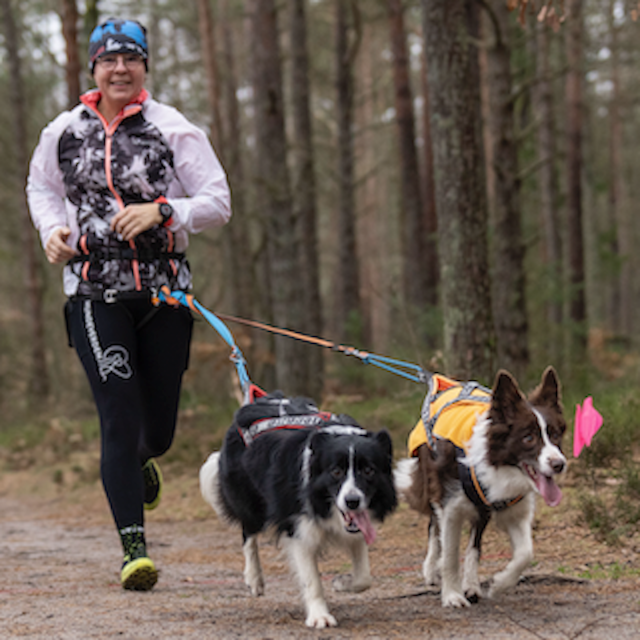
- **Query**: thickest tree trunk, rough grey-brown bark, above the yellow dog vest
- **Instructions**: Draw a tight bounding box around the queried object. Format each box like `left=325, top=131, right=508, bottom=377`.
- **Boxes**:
left=422, top=0, right=495, bottom=381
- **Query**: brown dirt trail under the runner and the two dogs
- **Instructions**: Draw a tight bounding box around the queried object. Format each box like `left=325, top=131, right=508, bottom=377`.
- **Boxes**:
left=0, top=472, right=640, bottom=640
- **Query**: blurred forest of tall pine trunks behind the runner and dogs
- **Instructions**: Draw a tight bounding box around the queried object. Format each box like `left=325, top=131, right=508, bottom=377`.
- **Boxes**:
left=0, top=0, right=640, bottom=460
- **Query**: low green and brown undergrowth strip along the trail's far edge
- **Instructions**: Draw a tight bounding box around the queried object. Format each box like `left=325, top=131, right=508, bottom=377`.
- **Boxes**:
left=0, top=348, right=640, bottom=545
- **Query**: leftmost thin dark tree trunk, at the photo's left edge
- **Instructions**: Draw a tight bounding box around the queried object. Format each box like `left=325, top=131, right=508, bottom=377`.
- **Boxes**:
left=0, top=0, right=50, bottom=399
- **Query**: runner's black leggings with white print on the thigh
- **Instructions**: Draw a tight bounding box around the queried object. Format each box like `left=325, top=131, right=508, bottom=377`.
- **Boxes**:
left=66, top=298, right=193, bottom=529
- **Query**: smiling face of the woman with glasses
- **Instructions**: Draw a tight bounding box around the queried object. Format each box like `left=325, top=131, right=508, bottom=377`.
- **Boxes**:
left=93, top=53, right=146, bottom=122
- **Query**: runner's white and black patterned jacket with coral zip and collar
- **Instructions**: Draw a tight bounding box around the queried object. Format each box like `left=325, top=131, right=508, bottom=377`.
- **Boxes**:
left=27, top=89, right=231, bottom=296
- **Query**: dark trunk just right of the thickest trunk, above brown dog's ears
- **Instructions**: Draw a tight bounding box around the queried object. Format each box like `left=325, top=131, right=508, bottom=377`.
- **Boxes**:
left=486, top=0, right=529, bottom=377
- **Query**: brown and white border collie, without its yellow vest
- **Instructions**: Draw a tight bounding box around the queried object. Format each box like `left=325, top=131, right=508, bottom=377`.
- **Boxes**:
left=396, top=367, right=567, bottom=607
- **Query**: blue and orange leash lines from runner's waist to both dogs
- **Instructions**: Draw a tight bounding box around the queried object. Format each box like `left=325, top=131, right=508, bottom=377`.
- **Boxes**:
left=156, top=287, right=433, bottom=388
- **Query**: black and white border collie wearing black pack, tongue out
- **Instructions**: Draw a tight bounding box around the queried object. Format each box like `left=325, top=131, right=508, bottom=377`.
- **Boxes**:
left=200, top=393, right=396, bottom=628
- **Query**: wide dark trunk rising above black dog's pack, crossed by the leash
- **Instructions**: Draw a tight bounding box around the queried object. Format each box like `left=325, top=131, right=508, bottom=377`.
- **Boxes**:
left=250, top=0, right=309, bottom=395
